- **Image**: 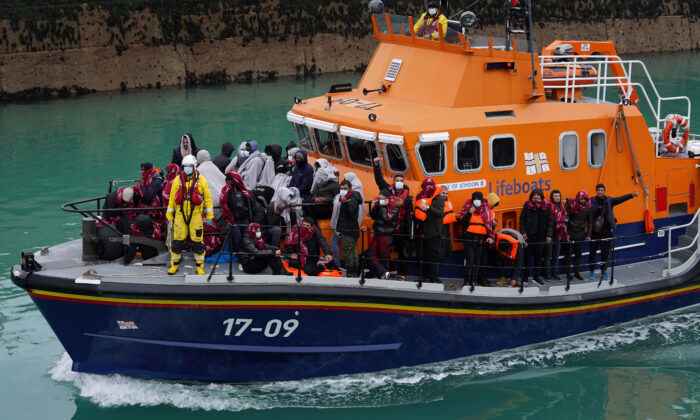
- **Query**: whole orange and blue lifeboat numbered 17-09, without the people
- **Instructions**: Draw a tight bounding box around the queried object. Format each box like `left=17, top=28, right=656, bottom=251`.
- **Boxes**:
left=11, top=0, right=700, bottom=382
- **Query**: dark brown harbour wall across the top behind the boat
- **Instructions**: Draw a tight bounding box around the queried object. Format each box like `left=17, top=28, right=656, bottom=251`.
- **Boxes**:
left=0, top=0, right=700, bottom=101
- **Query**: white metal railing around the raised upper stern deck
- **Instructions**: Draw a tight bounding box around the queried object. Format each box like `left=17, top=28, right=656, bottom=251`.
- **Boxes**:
left=540, top=55, right=691, bottom=134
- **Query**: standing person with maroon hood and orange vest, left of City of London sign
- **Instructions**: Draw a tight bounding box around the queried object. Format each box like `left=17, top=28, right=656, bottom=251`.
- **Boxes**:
left=413, top=178, right=445, bottom=283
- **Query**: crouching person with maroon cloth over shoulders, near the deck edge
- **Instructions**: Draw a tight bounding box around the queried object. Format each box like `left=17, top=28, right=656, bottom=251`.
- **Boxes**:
left=284, top=216, right=333, bottom=276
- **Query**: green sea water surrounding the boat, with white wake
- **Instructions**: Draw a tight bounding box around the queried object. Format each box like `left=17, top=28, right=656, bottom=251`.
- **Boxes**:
left=0, top=52, right=700, bottom=420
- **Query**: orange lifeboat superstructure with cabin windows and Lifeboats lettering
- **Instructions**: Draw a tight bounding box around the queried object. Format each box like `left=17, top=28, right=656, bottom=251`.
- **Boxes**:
left=287, top=15, right=699, bottom=249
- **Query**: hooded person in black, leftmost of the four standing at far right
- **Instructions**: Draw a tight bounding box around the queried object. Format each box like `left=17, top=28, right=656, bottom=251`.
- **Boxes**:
left=519, top=188, right=554, bottom=286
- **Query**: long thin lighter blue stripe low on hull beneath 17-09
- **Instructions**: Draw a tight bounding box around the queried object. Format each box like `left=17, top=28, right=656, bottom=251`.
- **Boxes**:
left=85, top=333, right=401, bottom=353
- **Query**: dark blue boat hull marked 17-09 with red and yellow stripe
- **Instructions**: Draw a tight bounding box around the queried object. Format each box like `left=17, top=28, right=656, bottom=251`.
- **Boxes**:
left=20, top=270, right=700, bottom=382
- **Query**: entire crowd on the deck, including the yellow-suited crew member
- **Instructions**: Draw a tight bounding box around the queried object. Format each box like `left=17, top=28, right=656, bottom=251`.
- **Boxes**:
left=100, top=134, right=637, bottom=287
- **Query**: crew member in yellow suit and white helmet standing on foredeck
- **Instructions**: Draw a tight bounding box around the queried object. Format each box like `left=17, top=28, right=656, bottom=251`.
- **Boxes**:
left=165, top=155, right=214, bottom=275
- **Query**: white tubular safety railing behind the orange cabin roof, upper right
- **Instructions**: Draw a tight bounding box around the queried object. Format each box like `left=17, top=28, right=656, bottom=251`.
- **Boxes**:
left=540, top=55, right=691, bottom=128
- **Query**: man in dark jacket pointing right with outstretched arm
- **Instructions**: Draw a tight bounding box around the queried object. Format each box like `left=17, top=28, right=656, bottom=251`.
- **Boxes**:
left=588, top=184, right=639, bottom=280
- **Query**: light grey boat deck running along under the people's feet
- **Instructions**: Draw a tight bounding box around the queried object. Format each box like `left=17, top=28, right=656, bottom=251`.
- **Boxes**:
left=30, top=240, right=683, bottom=297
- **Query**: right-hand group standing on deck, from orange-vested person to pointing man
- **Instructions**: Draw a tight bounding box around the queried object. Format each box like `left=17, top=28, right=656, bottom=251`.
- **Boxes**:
left=462, top=184, right=638, bottom=287
